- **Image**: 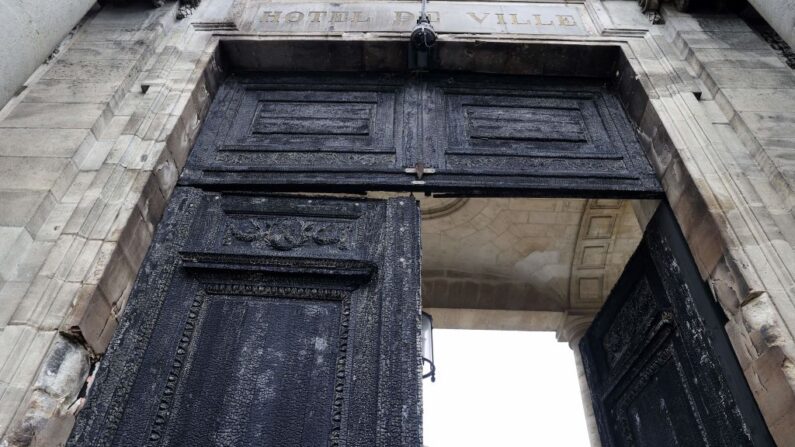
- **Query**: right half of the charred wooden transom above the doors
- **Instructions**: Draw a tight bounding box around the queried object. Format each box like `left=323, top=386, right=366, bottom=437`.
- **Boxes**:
left=424, top=77, right=658, bottom=196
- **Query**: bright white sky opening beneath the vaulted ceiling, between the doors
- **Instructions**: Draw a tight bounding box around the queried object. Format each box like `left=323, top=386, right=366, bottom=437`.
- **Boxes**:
left=423, top=329, right=590, bottom=447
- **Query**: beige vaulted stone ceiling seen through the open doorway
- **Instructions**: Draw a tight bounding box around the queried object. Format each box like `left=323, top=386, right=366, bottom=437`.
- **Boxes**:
left=420, top=197, right=641, bottom=312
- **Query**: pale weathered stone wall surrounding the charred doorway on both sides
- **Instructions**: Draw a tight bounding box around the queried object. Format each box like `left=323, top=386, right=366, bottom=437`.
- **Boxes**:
left=0, top=0, right=795, bottom=445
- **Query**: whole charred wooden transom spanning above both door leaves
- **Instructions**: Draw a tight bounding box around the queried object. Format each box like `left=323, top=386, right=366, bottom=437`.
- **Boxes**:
left=181, top=74, right=661, bottom=197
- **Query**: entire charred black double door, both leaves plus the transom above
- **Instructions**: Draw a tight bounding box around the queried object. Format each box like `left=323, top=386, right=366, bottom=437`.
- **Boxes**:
left=69, top=74, right=769, bottom=447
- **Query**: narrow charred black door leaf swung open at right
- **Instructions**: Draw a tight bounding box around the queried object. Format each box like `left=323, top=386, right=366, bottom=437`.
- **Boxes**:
left=580, top=204, right=775, bottom=447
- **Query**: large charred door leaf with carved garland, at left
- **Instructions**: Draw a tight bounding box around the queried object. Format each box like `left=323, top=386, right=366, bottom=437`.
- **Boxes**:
left=69, top=188, right=421, bottom=447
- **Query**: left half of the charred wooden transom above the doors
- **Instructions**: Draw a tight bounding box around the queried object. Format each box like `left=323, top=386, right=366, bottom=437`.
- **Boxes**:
left=183, top=75, right=418, bottom=190
